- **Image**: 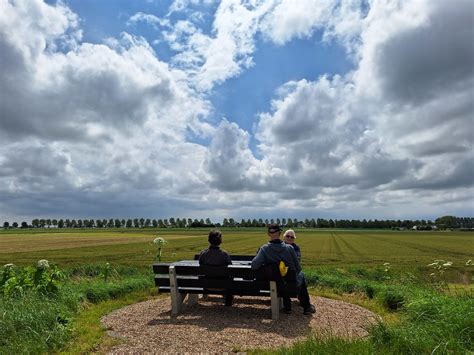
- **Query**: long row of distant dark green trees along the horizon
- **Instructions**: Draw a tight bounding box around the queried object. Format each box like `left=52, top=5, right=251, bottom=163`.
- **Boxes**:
left=3, top=216, right=474, bottom=230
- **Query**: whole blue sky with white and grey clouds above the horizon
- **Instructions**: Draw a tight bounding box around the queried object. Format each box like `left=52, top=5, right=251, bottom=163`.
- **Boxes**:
left=0, top=0, right=474, bottom=222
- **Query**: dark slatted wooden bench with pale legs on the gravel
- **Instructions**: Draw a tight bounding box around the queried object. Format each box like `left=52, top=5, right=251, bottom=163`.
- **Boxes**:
left=153, top=255, right=297, bottom=320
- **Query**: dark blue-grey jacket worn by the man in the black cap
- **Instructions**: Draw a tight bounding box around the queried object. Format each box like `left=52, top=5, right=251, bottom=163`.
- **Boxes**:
left=252, top=239, right=301, bottom=273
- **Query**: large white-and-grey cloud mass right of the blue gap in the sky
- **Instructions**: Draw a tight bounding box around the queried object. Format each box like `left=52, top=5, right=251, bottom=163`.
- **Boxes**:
left=205, top=1, right=474, bottom=211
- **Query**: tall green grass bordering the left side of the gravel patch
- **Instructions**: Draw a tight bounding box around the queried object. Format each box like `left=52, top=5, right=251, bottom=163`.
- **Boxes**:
left=0, top=265, right=153, bottom=354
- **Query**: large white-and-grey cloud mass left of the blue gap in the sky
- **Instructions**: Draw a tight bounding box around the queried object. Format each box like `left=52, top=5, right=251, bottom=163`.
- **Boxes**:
left=0, top=1, right=214, bottom=220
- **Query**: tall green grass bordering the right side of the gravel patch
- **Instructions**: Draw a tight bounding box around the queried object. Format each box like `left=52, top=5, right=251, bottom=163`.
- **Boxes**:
left=298, top=268, right=474, bottom=354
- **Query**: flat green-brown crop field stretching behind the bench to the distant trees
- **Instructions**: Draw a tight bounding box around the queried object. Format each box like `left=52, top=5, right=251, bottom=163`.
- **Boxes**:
left=0, top=229, right=474, bottom=268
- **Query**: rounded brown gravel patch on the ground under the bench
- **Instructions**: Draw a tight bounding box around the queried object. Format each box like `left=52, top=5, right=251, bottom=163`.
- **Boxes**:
left=102, top=297, right=378, bottom=354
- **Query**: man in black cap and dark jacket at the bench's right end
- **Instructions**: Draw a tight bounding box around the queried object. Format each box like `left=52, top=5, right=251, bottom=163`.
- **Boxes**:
left=251, top=224, right=316, bottom=315
